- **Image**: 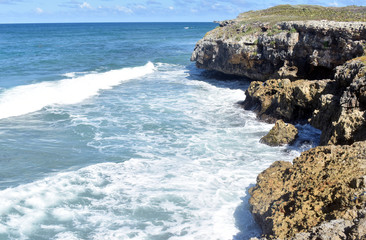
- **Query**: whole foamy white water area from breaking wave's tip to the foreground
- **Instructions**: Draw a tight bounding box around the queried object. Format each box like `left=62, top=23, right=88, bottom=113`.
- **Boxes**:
left=0, top=64, right=314, bottom=240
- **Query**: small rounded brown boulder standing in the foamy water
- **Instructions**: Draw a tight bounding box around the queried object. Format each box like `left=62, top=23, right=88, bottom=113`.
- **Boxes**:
left=260, top=120, right=299, bottom=146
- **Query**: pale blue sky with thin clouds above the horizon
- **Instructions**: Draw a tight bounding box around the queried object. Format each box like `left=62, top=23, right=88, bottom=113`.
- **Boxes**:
left=0, top=0, right=366, bottom=23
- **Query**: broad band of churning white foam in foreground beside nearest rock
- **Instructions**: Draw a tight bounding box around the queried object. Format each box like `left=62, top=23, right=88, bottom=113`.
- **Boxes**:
left=0, top=158, right=264, bottom=239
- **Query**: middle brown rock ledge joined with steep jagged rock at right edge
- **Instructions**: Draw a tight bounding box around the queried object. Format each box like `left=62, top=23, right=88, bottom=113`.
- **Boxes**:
left=243, top=57, right=366, bottom=145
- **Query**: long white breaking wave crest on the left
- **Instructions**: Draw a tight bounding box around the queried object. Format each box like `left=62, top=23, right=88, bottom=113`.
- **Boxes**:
left=0, top=62, right=155, bottom=119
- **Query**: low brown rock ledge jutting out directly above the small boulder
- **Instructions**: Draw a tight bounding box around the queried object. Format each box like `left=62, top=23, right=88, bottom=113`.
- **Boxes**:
left=243, top=79, right=335, bottom=122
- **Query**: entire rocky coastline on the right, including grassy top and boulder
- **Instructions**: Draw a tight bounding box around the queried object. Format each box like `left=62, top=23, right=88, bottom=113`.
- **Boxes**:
left=191, top=5, right=366, bottom=239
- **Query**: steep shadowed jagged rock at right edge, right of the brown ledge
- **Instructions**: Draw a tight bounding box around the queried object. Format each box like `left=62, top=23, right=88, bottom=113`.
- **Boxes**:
left=311, top=60, right=366, bottom=145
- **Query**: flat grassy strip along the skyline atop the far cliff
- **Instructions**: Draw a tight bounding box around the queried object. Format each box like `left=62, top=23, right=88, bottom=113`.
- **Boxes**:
left=237, top=5, right=366, bottom=24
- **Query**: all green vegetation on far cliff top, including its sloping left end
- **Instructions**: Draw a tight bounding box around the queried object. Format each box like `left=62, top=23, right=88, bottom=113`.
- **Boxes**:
left=206, top=5, right=366, bottom=41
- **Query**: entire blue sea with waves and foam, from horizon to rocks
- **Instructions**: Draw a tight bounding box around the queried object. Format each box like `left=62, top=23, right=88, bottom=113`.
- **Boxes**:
left=0, top=23, right=318, bottom=240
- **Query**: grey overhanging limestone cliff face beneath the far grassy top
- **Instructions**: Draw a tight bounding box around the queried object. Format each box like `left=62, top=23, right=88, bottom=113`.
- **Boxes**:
left=191, top=20, right=366, bottom=81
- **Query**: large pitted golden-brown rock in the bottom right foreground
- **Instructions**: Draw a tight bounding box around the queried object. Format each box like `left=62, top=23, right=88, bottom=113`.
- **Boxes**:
left=249, top=141, right=366, bottom=239
